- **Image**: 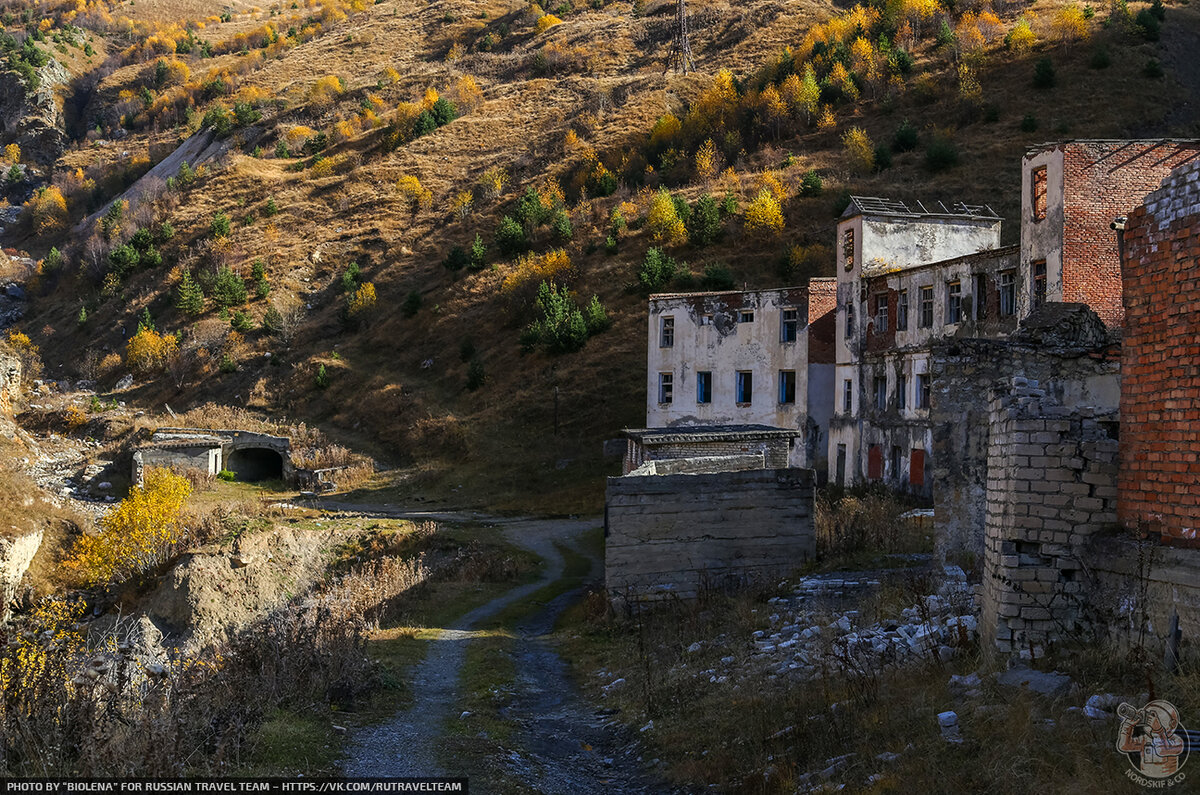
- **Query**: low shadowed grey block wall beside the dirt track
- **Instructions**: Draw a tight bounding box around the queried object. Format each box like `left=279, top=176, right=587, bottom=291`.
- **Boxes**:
left=605, top=468, right=816, bottom=599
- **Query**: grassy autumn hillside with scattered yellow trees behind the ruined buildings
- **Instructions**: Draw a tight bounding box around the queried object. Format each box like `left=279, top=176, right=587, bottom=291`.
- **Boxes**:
left=0, top=0, right=1200, bottom=512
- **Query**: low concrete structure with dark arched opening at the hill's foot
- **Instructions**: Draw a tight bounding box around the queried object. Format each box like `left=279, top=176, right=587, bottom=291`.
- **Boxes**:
left=133, top=428, right=292, bottom=485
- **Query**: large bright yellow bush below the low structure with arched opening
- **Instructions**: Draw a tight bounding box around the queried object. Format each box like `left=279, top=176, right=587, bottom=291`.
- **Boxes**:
left=66, top=468, right=192, bottom=585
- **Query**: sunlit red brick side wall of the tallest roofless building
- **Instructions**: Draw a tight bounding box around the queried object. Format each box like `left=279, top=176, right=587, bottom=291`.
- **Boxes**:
left=1062, top=141, right=1200, bottom=325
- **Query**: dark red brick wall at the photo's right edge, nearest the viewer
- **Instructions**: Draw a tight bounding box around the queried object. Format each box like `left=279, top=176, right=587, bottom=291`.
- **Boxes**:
left=1118, top=162, right=1200, bottom=544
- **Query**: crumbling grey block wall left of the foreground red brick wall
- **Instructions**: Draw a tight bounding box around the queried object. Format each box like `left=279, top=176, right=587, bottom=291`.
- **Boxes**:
left=980, top=378, right=1118, bottom=652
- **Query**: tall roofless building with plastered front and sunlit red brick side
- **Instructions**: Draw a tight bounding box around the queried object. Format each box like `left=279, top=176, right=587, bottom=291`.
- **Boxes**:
left=1020, top=139, right=1200, bottom=327
